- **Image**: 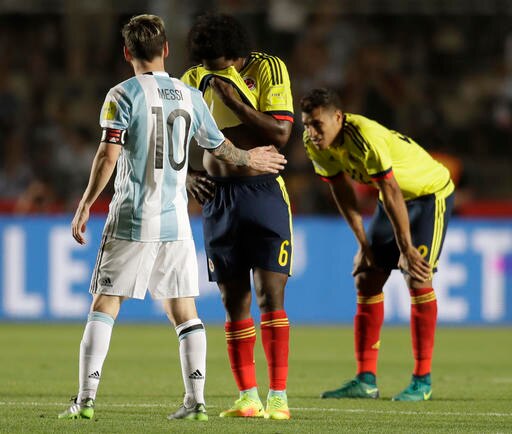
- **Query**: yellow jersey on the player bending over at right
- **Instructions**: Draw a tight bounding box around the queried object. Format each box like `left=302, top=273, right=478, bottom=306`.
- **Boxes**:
left=303, top=113, right=454, bottom=200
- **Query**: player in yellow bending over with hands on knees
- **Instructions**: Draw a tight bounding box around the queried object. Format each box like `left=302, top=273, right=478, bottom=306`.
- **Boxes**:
left=301, top=89, right=454, bottom=401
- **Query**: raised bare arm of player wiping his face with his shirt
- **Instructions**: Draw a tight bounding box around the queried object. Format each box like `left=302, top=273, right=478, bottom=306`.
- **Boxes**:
left=210, top=77, right=292, bottom=148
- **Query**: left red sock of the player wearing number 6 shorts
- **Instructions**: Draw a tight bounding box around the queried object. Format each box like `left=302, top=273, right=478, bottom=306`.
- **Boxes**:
left=224, top=318, right=256, bottom=390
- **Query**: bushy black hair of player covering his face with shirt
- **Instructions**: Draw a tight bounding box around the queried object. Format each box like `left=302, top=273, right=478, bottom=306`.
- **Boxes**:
left=188, top=13, right=251, bottom=63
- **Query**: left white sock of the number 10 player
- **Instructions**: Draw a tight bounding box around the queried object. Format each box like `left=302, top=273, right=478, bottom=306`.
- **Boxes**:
left=77, top=312, right=114, bottom=402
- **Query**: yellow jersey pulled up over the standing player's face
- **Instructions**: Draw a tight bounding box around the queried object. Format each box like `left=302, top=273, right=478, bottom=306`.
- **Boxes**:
left=181, top=52, right=293, bottom=129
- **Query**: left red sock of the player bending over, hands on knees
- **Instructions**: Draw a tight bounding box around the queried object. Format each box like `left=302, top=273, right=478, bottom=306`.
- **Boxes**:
left=354, top=292, right=384, bottom=375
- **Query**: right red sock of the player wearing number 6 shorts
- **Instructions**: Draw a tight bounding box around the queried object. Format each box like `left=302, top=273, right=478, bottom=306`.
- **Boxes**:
left=261, top=310, right=290, bottom=390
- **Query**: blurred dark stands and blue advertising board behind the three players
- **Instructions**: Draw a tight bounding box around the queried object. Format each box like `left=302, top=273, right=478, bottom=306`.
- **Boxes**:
left=0, top=0, right=512, bottom=324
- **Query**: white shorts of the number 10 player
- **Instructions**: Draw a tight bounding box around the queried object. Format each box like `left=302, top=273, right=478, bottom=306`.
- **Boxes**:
left=89, top=236, right=199, bottom=300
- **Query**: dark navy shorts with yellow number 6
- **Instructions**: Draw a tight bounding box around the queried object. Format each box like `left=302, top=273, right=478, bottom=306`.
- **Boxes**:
left=203, top=175, right=293, bottom=282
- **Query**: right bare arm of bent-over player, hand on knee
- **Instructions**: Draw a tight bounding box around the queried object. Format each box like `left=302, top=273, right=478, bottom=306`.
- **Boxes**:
left=378, top=176, right=432, bottom=282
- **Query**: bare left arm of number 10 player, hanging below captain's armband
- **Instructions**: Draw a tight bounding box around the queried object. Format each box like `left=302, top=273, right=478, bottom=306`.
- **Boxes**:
left=71, top=142, right=121, bottom=244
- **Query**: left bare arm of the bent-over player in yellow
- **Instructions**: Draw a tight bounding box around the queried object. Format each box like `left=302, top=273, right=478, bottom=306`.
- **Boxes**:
left=329, top=174, right=375, bottom=276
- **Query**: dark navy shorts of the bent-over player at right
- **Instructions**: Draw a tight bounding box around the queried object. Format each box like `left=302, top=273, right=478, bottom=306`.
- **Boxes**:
left=368, top=193, right=454, bottom=271
